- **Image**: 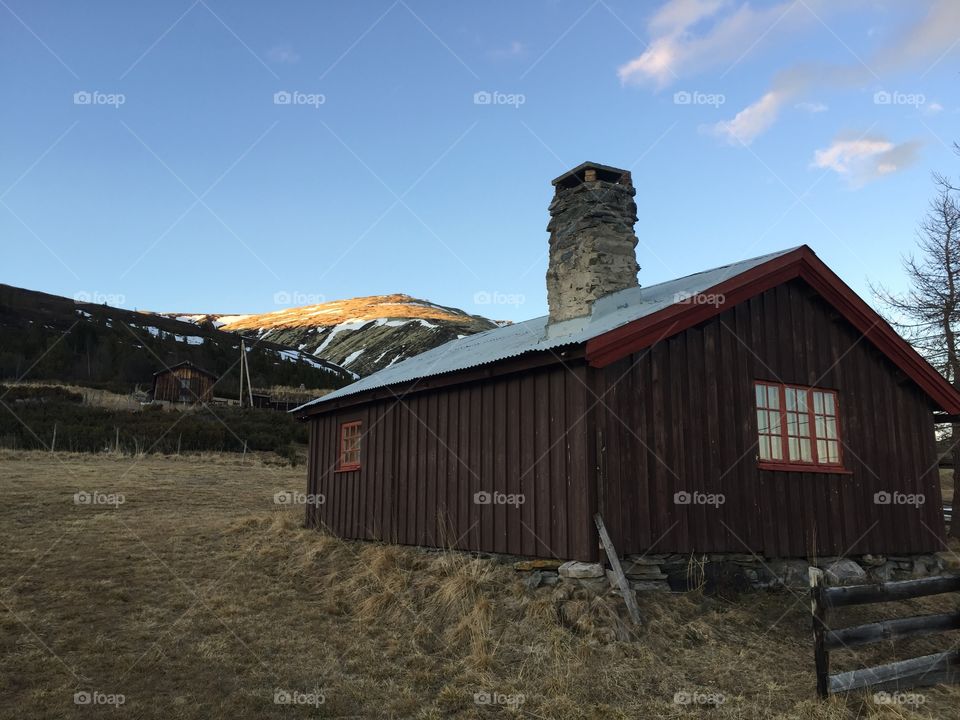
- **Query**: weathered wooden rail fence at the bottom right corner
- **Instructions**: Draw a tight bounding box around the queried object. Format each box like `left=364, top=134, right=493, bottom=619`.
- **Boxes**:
left=810, top=567, right=960, bottom=698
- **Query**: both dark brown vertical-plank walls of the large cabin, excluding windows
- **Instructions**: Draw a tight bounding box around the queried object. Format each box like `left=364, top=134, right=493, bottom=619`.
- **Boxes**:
left=307, top=280, right=943, bottom=560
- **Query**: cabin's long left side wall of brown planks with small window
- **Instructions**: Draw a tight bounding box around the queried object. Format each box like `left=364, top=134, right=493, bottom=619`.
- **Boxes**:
left=307, top=362, right=596, bottom=560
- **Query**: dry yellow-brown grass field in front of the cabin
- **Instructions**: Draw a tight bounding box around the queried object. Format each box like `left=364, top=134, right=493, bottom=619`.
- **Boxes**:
left=0, top=451, right=960, bottom=720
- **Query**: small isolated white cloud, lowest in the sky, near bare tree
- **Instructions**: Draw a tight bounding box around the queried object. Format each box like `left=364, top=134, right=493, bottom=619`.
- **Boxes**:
left=811, top=135, right=920, bottom=187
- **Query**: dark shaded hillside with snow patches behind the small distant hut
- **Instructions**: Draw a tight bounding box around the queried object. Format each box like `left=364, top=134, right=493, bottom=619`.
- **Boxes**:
left=0, top=284, right=355, bottom=397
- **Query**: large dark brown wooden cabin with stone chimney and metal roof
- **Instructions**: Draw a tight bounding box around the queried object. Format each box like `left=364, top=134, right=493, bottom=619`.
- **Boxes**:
left=297, top=163, right=960, bottom=561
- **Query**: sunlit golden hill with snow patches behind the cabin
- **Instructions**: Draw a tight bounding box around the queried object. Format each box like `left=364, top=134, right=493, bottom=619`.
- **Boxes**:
left=164, top=294, right=497, bottom=376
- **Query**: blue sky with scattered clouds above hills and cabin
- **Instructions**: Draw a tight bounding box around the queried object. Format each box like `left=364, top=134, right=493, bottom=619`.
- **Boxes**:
left=0, top=0, right=960, bottom=320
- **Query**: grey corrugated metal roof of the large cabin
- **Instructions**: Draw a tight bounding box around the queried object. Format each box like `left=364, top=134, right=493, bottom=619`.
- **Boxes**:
left=291, top=248, right=796, bottom=412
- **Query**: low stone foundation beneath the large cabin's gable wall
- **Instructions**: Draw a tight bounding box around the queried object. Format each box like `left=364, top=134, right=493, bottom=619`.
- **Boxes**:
left=513, top=552, right=960, bottom=594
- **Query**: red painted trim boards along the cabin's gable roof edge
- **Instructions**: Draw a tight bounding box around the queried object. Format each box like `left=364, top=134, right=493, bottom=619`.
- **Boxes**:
left=587, top=245, right=960, bottom=414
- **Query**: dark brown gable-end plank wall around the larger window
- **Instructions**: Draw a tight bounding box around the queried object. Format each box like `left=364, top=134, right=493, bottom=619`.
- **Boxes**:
left=591, top=280, right=943, bottom=557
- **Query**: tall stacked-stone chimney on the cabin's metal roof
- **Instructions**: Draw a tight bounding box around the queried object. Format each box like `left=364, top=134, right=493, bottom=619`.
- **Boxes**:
left=547, top=162, right=640, bottom=329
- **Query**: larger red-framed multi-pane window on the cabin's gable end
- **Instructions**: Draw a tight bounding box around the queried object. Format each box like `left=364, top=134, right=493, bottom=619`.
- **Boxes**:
left=754, top=380, right=850, bottom=474
